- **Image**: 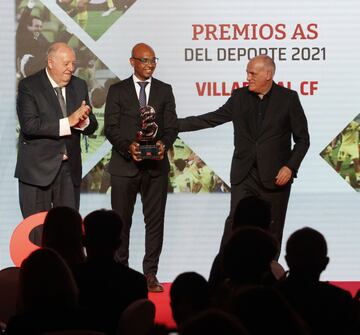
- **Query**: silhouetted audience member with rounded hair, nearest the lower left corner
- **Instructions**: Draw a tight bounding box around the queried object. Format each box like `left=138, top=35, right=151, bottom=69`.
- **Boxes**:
left=5, top=248, right=86, bottom=335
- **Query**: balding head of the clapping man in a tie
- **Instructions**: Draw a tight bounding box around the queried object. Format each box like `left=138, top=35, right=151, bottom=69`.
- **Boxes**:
left=47, top=42, right=76, bottom=87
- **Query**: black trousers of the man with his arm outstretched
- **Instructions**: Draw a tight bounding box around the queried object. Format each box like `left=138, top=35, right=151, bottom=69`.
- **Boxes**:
left=221, top=167, right=291, bottom=254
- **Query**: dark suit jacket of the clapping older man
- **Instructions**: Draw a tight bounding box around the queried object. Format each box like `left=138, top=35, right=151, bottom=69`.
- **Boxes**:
left=15, top=70, right=97, bottom=186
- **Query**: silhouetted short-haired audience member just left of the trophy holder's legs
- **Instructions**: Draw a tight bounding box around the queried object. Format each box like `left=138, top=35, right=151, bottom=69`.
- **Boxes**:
left=75, top=209, right=148, bottom=334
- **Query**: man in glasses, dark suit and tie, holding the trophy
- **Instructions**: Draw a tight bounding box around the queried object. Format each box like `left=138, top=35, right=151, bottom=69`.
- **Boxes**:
left=105, top=43, right=177, bottom=292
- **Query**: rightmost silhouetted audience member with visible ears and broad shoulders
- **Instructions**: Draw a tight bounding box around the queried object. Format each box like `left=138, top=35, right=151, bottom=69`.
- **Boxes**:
left=278, top=227, right=360, bottom=335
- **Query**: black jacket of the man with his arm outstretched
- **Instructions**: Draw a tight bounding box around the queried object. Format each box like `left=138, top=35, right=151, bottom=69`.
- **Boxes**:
left=178, top=83, right=310, bottom=189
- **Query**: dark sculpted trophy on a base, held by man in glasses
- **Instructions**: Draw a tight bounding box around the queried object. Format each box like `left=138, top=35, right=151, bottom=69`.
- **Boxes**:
left=136, top=105, right=159, bottom=159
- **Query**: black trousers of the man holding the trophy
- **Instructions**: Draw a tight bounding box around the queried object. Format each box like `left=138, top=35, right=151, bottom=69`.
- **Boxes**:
left=111, top=170, right=168, bottom=274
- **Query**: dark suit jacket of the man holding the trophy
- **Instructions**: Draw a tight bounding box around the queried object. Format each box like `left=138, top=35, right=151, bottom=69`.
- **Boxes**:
left=105, top=76, right=177, bottom=177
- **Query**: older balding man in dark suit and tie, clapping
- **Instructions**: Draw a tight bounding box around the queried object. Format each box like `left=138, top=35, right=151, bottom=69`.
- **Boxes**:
left=15, top=43, right=97, bottom=218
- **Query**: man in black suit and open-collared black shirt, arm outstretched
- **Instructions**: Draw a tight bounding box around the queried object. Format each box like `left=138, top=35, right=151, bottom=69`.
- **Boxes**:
left=179, top=55, right=310, bottom=252
